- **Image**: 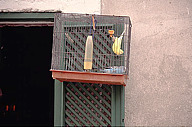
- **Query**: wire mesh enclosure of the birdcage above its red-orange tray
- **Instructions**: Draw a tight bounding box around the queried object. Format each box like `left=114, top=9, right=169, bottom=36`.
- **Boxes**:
left=51, top=13, right=130, bottom=74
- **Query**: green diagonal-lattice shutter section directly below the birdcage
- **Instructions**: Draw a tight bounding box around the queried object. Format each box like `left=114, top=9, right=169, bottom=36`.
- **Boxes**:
left=54, top=81, right=124, bottom=126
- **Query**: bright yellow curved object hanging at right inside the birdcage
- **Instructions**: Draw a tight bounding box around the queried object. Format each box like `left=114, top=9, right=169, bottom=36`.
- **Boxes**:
left=112, top=30, right=125, bottom=55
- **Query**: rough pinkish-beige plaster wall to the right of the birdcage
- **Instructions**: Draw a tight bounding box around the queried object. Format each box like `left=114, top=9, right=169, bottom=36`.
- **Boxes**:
left=102, top=0, right=192, bottom=126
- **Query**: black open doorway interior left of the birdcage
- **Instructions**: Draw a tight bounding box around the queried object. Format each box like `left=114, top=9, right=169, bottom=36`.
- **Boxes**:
left=0, top=26, right=54, bottom=126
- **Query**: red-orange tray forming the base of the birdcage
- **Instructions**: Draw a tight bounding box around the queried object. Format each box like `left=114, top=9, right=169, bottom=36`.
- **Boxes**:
left=50, top=70, right=128, bottom=86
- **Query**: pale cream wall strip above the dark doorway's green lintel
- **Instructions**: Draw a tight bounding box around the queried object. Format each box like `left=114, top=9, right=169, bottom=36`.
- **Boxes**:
left=0, top=0, right=101, bottom=14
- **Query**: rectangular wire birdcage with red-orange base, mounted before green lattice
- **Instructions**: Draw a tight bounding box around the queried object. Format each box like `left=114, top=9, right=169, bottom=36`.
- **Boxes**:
left=51, top=13, right=131, bottom=85
